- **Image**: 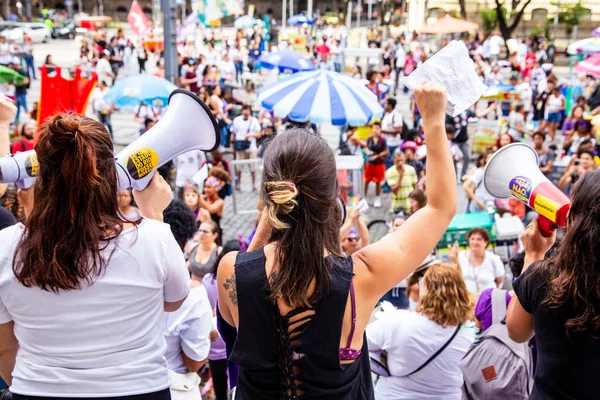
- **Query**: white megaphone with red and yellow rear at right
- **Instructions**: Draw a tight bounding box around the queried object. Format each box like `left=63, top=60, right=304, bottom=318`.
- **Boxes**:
left=483, top=143, right=571, bottom=237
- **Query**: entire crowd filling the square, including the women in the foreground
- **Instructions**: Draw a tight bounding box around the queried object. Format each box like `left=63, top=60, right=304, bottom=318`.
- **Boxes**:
left=0, top=17, right=600, bottom=400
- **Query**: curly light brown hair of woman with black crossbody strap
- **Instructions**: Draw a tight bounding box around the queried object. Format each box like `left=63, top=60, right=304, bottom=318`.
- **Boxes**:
left=417, top=264, right=473, bottom=327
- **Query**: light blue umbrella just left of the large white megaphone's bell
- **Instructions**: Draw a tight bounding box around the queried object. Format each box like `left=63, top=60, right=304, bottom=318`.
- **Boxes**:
left=106, top=74, right=177, bottom=107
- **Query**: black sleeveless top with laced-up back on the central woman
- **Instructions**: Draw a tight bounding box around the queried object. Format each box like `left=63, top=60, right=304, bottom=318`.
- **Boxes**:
left=230, top=249, right=374, bottom=400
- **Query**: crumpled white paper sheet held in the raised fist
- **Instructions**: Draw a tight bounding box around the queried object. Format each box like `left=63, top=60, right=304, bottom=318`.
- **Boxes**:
left=402, top=40, right=487, bottom=117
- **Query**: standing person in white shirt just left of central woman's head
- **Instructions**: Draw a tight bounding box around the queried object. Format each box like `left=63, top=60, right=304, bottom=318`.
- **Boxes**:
left=231, top=104, right=262, bottom=190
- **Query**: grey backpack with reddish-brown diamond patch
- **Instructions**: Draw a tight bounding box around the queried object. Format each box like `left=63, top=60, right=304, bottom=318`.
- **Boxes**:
left=460, top=289, right=533, bottom=400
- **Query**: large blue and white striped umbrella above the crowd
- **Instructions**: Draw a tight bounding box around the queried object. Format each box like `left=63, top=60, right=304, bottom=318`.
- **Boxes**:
left=258, top=69, right=383, bottom=126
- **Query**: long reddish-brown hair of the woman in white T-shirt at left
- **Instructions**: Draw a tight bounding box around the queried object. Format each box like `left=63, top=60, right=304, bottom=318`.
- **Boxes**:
left=13, top=114, right=123, bottom=292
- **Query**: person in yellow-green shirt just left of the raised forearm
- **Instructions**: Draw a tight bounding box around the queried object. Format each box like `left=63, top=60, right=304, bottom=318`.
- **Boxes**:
left=385, top=149, right=419, bottom=214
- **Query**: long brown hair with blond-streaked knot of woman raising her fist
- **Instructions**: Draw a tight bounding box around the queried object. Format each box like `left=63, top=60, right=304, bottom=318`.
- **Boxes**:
left=260, top=128, right=342, bottom=307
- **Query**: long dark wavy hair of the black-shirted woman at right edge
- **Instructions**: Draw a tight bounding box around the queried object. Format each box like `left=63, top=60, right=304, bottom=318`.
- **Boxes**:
left=535, top=170, right=600, bottom=339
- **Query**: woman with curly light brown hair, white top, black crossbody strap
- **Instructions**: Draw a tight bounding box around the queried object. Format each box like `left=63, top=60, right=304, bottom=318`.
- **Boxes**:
left=367, top=264, right=475, bottom=400
